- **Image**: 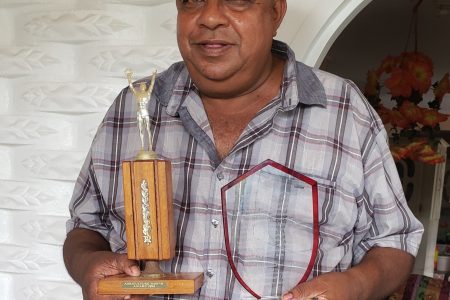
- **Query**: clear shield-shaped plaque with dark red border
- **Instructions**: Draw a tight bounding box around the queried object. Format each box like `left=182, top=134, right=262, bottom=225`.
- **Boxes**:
left=222, top=160, right=319, bottom=298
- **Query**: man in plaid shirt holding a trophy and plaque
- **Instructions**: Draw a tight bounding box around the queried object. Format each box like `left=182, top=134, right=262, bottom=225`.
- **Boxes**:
left=64, top=0, right=422, bottom=299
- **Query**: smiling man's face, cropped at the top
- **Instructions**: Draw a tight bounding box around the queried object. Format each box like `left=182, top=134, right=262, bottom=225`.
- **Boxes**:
left=177, top=0, right=285, bottom=94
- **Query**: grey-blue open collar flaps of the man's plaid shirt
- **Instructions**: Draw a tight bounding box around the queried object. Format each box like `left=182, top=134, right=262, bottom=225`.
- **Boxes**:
left=155, top=40, right=326, bottom=116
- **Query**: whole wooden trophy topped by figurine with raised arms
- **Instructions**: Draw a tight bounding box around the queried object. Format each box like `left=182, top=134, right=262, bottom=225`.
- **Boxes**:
left=97, top=70, right=203, bottom=295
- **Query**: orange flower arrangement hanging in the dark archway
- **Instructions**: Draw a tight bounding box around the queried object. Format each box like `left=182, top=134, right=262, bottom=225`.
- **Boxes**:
left=364, top=51, right=450, bottom=164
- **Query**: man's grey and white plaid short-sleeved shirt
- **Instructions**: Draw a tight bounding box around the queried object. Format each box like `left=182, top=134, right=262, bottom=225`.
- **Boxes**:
left=67, top=41, right=423, bottom=299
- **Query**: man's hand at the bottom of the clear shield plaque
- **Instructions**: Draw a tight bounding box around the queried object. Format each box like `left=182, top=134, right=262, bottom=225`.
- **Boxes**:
left=283, top=272, right=359, bottom=300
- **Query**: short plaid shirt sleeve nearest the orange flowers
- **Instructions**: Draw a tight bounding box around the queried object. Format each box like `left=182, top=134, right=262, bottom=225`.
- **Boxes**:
left=353, top=129, right=423, bottom=264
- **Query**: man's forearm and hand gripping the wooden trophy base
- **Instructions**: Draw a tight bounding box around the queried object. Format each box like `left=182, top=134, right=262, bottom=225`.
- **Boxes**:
left=63, top=229, right=145, bottom=300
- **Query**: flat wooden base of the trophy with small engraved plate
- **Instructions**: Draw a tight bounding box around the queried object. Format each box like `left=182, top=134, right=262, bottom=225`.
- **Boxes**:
left=97, top=272, right=203, bottom=295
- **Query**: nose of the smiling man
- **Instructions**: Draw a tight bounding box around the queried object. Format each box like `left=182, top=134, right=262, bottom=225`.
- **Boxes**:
left=198, top=0, right=228, bottom=30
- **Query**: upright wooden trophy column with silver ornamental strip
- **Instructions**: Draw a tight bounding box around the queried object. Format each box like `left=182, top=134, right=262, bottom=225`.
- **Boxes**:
left=122, top=160, right=175, bottom=260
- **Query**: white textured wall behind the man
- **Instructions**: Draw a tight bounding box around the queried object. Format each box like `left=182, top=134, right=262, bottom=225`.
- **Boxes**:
left=0, top=0, right=369, bottom=300
